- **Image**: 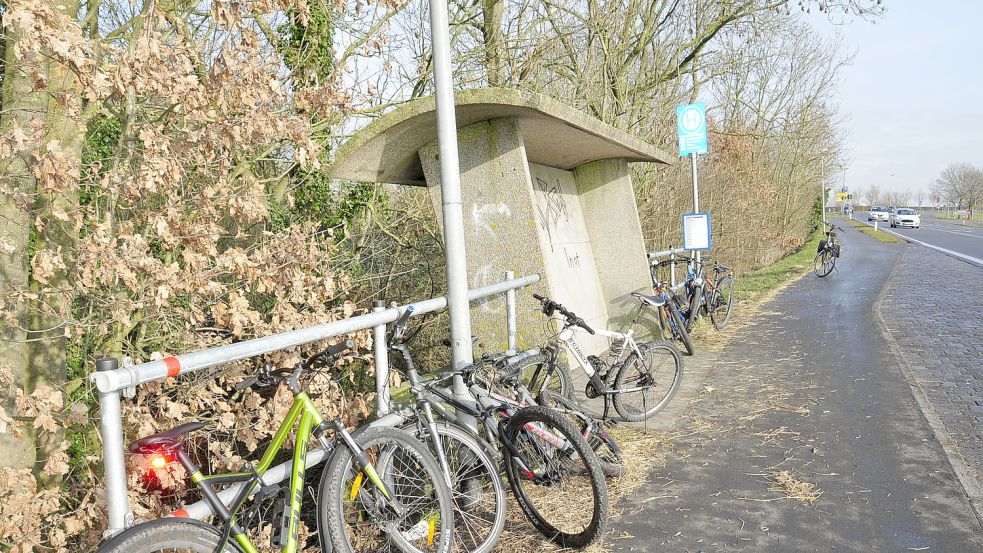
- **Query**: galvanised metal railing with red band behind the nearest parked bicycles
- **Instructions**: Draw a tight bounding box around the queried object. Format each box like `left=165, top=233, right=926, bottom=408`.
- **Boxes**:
left=90, top=271, right=540, bottom=534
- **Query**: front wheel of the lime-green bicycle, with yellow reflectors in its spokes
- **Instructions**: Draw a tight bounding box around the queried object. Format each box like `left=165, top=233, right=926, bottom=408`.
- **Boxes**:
left=317, top=427, right=454, bottom=553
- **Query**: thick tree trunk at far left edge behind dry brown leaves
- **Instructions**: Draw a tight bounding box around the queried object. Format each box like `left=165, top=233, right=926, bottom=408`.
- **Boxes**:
left=0, top=0, right=84, bottom=478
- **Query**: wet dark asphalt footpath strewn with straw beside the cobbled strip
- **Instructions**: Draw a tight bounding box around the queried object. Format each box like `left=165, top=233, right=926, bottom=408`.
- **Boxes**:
left=607, top=223, right=983, bottom=553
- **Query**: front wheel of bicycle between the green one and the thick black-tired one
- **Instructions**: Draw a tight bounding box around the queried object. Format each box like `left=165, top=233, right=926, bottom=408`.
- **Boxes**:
left=403, top=421, right=507, bottom=553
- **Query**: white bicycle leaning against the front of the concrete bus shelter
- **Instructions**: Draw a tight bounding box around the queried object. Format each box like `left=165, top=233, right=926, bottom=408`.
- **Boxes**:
left=513, top=294, right=683, bottom=421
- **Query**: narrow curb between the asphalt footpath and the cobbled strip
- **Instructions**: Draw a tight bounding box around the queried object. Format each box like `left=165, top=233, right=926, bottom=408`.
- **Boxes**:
left=872, top=245, right=983, bottom=526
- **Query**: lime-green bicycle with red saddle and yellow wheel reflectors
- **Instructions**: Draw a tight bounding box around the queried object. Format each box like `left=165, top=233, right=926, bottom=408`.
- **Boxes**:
left=99, top=342, right=454, bottom=553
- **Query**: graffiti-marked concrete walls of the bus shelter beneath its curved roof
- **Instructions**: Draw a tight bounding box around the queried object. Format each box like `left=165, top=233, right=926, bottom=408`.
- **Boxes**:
left=419, top=118, right=651, bottom=355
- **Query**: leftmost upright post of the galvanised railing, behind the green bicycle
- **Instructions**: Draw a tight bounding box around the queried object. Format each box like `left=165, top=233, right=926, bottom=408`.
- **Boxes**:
left=96, top=357, right=133, bottom=537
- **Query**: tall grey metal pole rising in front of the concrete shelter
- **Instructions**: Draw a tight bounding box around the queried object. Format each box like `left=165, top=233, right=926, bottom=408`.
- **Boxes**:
left=430, top=0, right=474, bottom=410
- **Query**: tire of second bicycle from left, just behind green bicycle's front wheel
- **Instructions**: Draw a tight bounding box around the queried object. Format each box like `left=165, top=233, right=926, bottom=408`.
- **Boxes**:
left=403, top=421, right=508, bottom=553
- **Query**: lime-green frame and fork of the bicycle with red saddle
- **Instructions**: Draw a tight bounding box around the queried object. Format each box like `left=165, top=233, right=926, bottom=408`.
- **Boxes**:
left=174, top=392, right=394, bottom=553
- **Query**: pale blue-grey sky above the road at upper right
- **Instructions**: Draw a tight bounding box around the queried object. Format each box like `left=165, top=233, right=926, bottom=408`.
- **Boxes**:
left=815, top=0, right=983, bottom=196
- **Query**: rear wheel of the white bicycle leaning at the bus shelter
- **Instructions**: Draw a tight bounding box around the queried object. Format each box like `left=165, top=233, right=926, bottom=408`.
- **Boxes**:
left=611, top=340, right=683, bottom=422
